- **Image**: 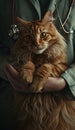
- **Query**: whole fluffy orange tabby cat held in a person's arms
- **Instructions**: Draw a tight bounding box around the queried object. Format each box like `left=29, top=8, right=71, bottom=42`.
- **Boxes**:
left=13, top=11, right=75, bottom=130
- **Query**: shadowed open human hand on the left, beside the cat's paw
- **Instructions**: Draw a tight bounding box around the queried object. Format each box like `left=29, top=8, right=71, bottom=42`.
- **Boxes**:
left=4, top=64, right=29, bottom=92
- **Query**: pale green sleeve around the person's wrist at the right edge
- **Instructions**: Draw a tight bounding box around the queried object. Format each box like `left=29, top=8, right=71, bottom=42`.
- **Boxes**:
left=61, top=31, right=75, bottom=97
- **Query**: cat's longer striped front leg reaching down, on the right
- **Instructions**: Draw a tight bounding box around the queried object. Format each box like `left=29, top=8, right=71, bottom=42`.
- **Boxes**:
left=30, top=64, right=50, bottom=92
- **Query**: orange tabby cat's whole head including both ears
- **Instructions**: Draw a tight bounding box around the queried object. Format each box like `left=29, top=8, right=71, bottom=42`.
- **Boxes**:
left=16, top=12, right=56, bottom=54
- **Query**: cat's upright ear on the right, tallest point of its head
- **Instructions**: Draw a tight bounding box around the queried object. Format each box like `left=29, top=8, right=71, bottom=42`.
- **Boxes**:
left=41, top=10, right=54, bottom=24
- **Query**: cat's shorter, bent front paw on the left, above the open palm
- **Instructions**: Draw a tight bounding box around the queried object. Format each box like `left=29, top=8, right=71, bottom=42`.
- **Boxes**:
left=20, top=61, right=35, bottom=83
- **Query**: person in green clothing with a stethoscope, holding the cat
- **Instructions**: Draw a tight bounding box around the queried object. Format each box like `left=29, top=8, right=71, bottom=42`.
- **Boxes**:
left=0, top=0, right=75, bottom=129
